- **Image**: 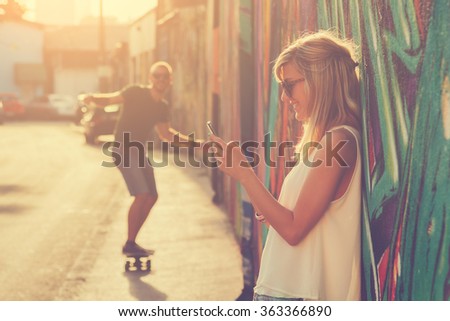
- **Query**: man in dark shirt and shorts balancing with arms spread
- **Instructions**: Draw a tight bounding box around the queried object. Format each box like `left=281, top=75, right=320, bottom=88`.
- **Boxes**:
left=84, top=61, right=200, bottom=255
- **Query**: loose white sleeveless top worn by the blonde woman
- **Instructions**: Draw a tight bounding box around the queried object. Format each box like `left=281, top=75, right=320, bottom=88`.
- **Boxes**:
left=255, top=126, right=362, bottom=300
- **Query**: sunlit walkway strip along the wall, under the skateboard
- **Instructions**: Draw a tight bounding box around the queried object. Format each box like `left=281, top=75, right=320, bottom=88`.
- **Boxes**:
left=59, top=150, right=243, bottom=301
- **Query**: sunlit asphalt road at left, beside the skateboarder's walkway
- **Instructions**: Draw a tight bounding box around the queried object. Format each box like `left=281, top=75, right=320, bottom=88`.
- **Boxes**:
left=0, top=122, right=124, bottom=300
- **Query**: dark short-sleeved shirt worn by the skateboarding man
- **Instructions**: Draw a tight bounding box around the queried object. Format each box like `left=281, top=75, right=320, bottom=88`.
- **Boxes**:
left=115, top=85, right=170, bottom=143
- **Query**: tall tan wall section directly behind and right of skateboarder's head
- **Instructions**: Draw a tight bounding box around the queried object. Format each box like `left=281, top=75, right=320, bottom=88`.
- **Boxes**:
left=156, top=1, right=209, bottom=138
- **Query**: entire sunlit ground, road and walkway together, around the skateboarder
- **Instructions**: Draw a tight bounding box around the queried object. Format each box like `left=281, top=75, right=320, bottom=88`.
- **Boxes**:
left=0, top=121, right=242, bottom=301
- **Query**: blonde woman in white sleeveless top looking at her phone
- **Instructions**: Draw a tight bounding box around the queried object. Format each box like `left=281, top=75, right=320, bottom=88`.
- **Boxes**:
left=211, top=31, right=361, bottom=300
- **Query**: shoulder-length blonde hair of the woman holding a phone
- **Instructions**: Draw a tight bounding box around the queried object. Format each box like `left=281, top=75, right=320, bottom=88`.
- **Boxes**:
left=273, top=31, right=361, bottom=153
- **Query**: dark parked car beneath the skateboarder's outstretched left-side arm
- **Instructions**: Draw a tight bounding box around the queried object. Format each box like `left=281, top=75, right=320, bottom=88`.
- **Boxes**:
left=80, top=104, right=121, bottom=144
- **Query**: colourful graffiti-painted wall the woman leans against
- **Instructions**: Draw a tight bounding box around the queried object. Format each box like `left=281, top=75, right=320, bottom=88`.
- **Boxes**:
left=246, top=0, right=450, bottom=300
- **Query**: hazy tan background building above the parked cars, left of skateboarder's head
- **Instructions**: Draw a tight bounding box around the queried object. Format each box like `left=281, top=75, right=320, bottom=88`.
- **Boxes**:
left=45, top=25, right=128, bottom=95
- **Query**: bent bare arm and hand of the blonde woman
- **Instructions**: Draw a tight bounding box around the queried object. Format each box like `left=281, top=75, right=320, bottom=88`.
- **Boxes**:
left=211, top=132, right=356, bottom=245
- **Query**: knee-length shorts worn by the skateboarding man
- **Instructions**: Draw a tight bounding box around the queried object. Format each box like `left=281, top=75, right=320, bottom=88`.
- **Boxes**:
left=116, top=146, right=158, bottom=196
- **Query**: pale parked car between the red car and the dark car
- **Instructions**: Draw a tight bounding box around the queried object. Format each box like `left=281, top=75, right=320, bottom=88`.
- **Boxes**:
left=26, top=94, right=76, bottom=119
